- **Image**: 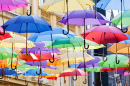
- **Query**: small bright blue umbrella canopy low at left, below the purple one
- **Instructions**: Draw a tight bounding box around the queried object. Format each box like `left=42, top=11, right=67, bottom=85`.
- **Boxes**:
left=23, top=69, right=48, bottom=76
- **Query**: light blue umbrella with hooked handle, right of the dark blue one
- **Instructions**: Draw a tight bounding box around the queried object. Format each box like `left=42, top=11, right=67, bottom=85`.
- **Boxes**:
left=28, top=27, right=76, bottom=63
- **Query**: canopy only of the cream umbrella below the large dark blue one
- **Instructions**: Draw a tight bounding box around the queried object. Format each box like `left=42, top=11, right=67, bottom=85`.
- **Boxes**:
left=0, top=34, right=35, bottom=48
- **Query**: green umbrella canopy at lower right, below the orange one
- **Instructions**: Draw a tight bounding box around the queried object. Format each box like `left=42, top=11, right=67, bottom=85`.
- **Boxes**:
left=98, top=54, right=128, bottom=68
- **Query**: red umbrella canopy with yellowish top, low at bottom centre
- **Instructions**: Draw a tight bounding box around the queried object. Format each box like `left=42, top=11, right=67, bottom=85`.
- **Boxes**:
left=59, top=68, right=88, bottom=77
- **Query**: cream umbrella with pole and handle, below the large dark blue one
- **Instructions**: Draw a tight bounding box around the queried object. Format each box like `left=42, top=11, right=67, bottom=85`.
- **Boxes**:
left=1, top=34, right=35, bottom=70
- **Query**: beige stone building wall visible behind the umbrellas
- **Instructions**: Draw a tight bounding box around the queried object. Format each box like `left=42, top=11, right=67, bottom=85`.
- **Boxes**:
left=0, top=0, right=87, bottom=86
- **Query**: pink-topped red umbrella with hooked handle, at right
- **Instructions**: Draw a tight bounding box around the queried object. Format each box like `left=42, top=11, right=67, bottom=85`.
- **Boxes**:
left=81, top=25, right=128, bottom=61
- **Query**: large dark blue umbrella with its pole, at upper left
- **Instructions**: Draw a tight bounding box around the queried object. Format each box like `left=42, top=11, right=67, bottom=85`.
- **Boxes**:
left=4, top=13, right=51, bottom=54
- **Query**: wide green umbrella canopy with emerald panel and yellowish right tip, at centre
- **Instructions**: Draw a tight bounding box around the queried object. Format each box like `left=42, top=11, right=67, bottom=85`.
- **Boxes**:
left=46, top=36, right=103, bottom=49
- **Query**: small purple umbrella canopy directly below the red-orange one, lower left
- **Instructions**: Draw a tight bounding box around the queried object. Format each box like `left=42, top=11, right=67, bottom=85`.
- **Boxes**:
left=24, top=61, right=57, bottom=69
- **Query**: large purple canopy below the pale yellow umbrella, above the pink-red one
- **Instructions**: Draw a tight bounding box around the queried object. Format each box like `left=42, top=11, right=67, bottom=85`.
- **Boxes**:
left=59, top=10, right=109, bottom=26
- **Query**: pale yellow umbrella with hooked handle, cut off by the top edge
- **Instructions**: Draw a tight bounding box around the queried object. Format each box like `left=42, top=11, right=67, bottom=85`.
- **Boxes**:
left=41, top=0, right=94, bottom=35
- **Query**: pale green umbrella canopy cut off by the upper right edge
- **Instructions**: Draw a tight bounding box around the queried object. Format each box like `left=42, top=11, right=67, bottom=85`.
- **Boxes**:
left=111, top=10, right=130, bottom=25
